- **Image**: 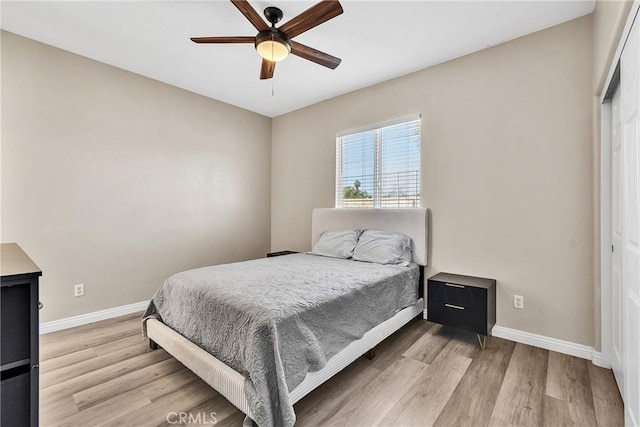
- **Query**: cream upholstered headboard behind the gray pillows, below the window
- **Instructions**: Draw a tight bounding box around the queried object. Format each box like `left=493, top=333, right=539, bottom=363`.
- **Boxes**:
left=311, top=208, right=428, bottom=265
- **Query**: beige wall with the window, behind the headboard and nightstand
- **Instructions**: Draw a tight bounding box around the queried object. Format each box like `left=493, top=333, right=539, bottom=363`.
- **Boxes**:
left=271, top=15, right=594, bottom=345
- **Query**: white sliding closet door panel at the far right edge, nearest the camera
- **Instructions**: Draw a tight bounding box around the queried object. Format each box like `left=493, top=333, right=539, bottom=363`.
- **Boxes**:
left=614, top=16, right=640, bottom=425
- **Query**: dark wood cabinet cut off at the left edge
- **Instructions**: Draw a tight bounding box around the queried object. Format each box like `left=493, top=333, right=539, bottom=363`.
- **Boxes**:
left=0, top=243, right=42, bottom=427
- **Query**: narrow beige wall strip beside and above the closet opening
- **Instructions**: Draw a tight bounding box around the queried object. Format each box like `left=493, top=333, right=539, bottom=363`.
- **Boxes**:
left=592, top=0, right=633, bottom=350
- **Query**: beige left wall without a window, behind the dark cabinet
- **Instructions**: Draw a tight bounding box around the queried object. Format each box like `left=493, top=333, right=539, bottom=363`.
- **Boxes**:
left=1, top=32, right=271, bottom=321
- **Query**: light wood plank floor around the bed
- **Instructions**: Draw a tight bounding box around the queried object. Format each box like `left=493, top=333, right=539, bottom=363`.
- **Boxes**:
left=40, top=314, right=623, bottom=426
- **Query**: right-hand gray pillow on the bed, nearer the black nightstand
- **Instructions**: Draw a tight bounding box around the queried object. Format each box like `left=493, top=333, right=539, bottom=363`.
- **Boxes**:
left=353, top=230, right=411, bottom=267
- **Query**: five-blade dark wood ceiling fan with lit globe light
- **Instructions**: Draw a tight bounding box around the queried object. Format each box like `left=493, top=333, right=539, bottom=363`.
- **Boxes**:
left=191, top=0, right=343, bottom=79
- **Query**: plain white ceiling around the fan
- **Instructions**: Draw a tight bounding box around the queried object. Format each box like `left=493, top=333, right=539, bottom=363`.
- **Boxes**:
left=1, top=0, right=595, bottom=117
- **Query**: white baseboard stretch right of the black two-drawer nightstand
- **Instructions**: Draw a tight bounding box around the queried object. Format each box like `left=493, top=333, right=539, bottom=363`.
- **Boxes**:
left=491, top=325, right=607, bottom=367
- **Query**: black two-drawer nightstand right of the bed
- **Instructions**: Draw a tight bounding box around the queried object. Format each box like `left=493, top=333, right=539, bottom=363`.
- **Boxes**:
left=427, top=273, right=496, bottom=349
